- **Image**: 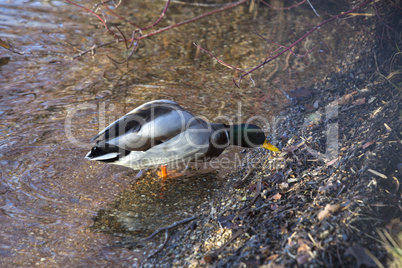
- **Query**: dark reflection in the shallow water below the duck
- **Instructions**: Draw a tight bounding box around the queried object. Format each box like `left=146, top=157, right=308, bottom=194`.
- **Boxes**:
left=93, top=172, right=223, bottom=240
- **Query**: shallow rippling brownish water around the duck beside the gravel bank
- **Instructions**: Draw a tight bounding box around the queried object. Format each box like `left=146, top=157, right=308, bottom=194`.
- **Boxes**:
left=0, top=0, right=362, bottom=266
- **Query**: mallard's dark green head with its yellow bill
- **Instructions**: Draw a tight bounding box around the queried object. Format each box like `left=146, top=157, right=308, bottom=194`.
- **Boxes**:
left=228, top=124, right=279, bottom=152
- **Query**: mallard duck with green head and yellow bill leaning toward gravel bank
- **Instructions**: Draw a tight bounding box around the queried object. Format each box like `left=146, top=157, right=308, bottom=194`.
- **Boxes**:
left=85, top=100, right=279, bottom=175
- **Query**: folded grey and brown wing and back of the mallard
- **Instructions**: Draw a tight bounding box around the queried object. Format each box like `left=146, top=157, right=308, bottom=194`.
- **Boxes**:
left=92, top=100, right=194, bottom=151
